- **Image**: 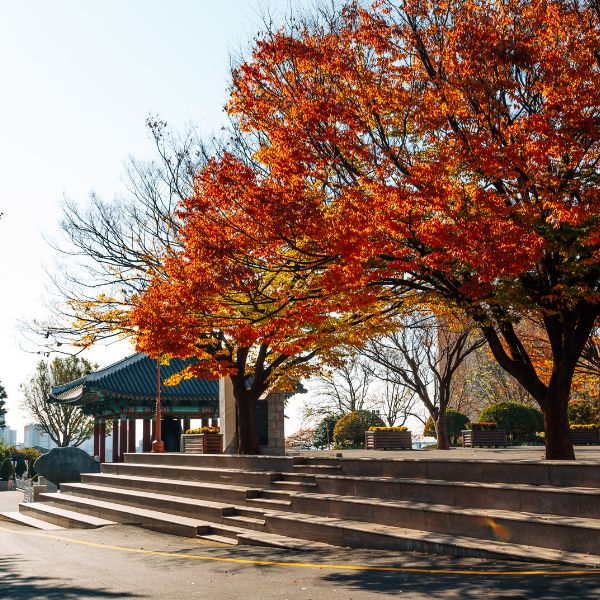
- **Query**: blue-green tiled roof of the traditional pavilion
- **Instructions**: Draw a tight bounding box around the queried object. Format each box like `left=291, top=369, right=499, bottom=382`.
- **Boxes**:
left=52, top=353, right=219, bottom=401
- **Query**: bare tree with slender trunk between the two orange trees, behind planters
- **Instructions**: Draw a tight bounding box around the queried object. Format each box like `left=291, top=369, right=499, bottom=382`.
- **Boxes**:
left=361, top=312, right=485, bottom=450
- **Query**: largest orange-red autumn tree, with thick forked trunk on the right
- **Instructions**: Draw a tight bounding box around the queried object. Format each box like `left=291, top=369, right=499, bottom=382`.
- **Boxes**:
left=227, top=0, right=600, bottom=459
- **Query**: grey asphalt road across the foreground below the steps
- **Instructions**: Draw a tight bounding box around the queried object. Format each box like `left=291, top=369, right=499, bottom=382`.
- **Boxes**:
left=0, top=521, right=600, bottom=600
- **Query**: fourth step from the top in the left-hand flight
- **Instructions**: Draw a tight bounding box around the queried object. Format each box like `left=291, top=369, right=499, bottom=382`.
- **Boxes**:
left=61, top=483, right=236, bottom=521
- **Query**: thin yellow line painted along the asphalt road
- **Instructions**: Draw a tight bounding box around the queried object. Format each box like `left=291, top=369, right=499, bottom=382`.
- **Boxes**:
left=0, top=527, right=600, bottom=577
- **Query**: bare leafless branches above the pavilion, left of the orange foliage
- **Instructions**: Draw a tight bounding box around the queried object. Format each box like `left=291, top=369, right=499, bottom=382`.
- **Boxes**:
left=24, top=119, right=207, bottom=352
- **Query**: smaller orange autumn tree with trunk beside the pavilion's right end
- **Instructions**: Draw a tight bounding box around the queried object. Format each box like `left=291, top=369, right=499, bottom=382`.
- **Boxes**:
left=131, top=156, right=378, bottom=454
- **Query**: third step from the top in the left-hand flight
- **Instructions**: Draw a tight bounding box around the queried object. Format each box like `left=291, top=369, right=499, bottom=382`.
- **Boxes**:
left=81, top=473, right=261, bottom=505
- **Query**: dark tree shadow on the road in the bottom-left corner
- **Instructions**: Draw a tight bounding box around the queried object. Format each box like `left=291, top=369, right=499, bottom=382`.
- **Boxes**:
left=0, top=556, right=141, bottom=600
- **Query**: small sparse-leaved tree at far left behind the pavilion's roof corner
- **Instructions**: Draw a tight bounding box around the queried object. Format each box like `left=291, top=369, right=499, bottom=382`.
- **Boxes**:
left=20, top=356, right=97, bottom=447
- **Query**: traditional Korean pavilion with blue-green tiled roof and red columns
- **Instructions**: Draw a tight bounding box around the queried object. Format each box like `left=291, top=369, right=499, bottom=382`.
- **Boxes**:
left=50, top=353, right=219, bottom=462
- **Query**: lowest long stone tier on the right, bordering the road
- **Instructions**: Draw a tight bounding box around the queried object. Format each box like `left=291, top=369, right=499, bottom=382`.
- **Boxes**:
left=265, top=513, right=600, bottom=568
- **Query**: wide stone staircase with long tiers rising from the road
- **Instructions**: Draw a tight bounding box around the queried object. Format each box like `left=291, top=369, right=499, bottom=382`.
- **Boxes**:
left=7, top=454, right=600, bottom=567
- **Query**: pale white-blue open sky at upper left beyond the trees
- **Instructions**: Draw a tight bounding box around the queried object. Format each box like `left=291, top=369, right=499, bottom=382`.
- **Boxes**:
left=0, top=0, right=313, bottom=440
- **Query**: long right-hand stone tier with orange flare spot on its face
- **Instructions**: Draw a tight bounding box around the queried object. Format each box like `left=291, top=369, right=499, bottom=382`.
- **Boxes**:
left=291, top=494, right=600, bottom=555
